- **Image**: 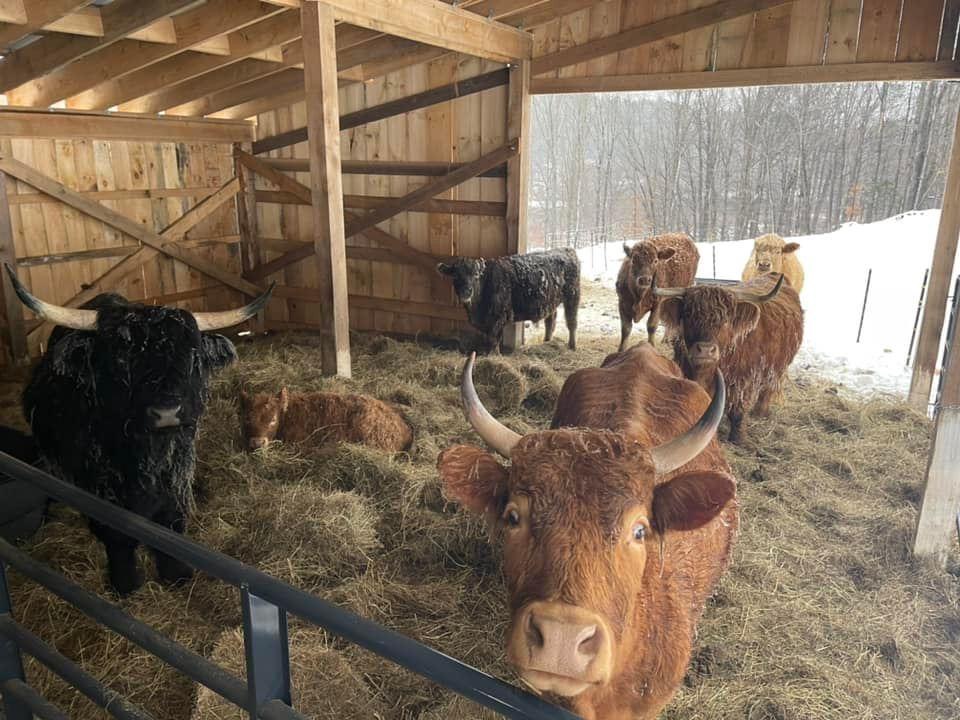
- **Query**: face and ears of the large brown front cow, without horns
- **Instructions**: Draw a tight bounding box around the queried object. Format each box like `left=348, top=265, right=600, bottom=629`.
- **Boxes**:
left=439, top=430, right=735, bottom=697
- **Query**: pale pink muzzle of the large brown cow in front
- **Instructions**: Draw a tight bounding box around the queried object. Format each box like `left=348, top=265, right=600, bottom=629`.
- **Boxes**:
left=511, top=602, right=611, bottom=694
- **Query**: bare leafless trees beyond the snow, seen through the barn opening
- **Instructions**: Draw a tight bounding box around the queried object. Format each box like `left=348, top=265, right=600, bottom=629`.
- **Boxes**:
left=529, top=82, right=960, bottom=247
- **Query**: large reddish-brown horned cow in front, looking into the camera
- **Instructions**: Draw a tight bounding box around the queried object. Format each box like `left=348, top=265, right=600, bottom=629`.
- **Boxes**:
left=438, top=344, right=739, bottom=720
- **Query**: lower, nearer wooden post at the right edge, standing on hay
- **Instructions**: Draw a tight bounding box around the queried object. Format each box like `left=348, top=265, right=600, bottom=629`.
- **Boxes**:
left=913, top=296, right=960, bottom=565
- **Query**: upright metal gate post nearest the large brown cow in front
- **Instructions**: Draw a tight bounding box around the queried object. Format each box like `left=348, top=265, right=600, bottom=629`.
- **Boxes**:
left=240, top=585, right=293, bottom=720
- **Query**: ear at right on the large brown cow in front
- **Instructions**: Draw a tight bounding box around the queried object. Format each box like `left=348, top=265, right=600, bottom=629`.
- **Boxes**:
left=653, top=470, right=737, bottom=533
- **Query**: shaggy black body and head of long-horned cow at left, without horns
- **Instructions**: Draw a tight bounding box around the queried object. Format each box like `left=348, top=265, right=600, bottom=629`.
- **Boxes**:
left=23, top=294, right=236, bottom=594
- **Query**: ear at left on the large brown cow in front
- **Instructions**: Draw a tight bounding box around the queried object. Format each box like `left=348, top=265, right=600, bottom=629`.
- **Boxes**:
left=437, top=445, right=509, bottom=517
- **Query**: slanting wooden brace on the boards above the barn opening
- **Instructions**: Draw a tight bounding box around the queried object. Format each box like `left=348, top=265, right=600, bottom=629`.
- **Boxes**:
left=530, top=0, right=785, bottom=75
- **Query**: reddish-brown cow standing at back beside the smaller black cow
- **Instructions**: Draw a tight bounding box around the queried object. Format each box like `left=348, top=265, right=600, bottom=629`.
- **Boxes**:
left=617, top=233, right=700, bottom=352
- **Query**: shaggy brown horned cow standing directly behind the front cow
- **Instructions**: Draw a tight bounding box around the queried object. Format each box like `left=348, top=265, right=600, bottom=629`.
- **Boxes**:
left=654, top=274, right=803, bottom=442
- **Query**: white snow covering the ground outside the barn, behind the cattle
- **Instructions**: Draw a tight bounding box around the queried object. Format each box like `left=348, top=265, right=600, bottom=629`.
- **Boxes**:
left=578, top=210, right=940, bottom=395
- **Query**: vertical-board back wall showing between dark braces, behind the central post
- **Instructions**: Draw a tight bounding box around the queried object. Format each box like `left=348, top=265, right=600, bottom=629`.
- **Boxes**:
left=257, top=54, right=507, bottom=334
